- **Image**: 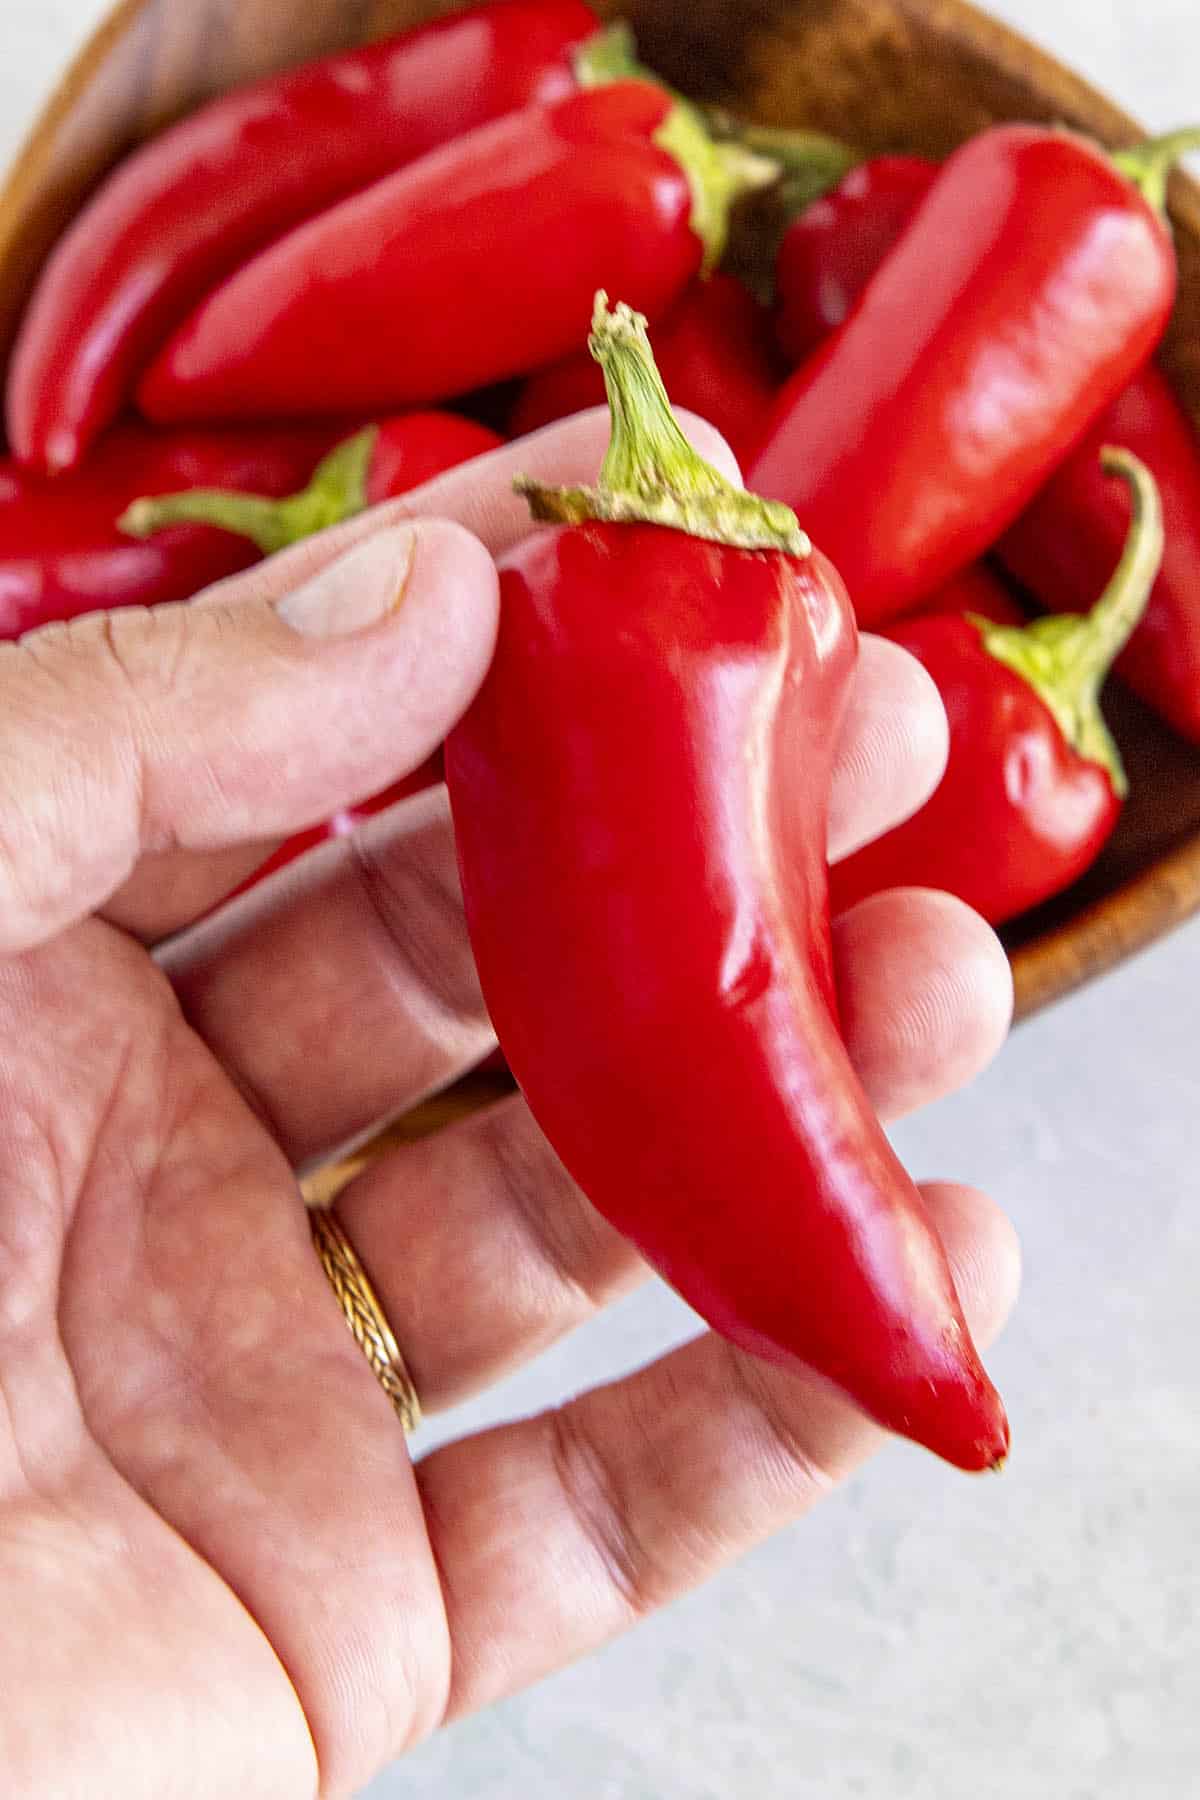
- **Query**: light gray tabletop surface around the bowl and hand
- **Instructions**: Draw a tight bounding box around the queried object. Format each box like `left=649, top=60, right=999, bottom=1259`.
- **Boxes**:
left=0, top=0, right=1200, bottom=1800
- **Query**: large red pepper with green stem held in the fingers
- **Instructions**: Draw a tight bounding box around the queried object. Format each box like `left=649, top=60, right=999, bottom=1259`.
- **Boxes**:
left=446, top=308, right=1007, bottom=1469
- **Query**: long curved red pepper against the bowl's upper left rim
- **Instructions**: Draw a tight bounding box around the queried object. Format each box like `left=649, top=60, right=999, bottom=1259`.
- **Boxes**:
left=7, top=0, right=603, bottom=470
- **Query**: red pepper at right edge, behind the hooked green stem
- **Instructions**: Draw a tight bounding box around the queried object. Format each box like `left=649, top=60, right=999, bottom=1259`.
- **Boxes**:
left=997, top=364, right=1200, bottom=743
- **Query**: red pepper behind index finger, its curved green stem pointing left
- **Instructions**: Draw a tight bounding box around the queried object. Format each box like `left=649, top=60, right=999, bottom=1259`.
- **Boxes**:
left=116, top=412, right=504, bottom=556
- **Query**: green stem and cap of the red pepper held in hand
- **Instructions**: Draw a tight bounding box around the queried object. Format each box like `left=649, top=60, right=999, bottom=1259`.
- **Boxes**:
left=516, top=293, right=811, bottom=556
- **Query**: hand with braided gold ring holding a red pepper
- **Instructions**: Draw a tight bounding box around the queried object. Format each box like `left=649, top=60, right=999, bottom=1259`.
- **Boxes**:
left=0, top=414, right=1016, bottom=1800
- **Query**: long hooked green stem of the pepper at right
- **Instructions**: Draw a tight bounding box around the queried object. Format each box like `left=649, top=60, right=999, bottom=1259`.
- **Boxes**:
left=972, top=448, right=1162, bottom=797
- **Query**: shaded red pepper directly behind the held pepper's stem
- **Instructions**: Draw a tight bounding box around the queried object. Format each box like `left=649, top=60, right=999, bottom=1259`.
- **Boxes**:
left=511, top=275, right=779, bottom=457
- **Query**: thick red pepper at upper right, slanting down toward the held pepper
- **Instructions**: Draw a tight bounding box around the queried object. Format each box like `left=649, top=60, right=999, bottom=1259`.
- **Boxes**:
left=748, top=126, right=1195, bottom=625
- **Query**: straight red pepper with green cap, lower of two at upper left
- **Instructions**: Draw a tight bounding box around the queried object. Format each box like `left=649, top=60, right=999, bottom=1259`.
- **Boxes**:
left=139, top=81, right=775, bottom=419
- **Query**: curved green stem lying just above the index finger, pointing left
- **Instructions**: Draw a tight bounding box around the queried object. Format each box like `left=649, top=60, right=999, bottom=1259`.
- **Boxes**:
left=117, top=425, right=380, bottom=556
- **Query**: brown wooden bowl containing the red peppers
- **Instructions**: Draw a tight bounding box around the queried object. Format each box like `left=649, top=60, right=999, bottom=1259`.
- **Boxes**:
left=0, top=0, right=1200, bottom=1036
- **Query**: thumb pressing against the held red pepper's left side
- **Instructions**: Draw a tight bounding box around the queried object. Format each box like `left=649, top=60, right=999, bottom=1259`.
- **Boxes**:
left=0, top=520, right=498, bottom=952
